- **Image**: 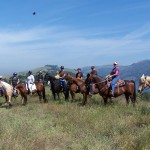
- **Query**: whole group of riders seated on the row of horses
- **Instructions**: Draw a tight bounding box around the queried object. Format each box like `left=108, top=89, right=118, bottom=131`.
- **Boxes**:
left=0, top=62, right=120, bottom=97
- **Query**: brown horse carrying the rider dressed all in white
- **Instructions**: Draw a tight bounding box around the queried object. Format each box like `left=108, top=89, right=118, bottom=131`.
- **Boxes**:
left=15, top=82, right=47, bottom=105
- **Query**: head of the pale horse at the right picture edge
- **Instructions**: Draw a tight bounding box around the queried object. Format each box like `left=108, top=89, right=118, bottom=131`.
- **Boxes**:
left=138, top=74, right=150, bottom=92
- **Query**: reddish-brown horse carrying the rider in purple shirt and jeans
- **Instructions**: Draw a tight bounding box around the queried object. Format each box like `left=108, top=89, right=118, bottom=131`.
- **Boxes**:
left=84, top=74, right=136, bottom=105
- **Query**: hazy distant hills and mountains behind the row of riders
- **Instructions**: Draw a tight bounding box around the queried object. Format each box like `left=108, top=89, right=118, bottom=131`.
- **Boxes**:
left=1, top=60, right=150, bottom=88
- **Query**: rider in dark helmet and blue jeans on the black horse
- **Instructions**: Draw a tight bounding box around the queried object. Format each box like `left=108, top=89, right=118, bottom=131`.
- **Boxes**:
left=59, top=66, right=67, bottom=92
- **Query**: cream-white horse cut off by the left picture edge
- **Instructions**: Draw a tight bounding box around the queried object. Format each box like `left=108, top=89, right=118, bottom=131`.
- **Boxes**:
left=1, top=81, right=13, bottom=107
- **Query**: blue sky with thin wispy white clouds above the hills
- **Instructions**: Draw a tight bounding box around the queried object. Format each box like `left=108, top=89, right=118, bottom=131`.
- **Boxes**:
left=0, top=0, right=150, bottom=73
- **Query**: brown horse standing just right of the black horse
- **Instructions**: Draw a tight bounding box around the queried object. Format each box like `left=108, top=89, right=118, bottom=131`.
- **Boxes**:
left=65, top=75, right=89, bottom=101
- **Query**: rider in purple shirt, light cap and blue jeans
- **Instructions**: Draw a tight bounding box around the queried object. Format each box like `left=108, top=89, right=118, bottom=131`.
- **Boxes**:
left=107, top=62, right=120, bottom=97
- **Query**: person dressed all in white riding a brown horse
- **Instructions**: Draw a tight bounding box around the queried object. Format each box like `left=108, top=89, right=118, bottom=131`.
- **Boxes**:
left=26, top=71, right=35, bottom=94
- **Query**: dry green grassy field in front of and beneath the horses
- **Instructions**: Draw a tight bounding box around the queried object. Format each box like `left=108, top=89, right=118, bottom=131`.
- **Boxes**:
left=0, top=86, right=150, bottom=150
